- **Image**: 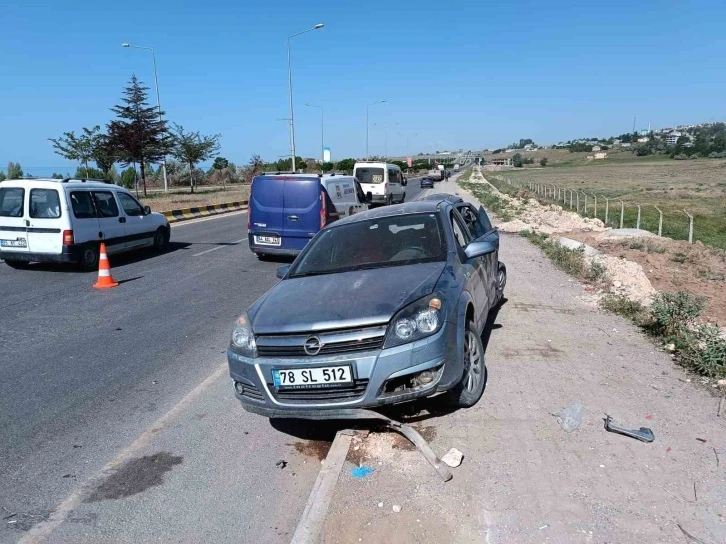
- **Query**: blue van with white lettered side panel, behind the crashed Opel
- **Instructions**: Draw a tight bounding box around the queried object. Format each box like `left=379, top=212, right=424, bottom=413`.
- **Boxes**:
left=247, top=173, right=368, bottom=258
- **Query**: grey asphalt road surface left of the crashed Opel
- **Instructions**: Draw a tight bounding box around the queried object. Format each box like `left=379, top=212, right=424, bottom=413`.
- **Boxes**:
left=0, top=179, right=430, bottom=542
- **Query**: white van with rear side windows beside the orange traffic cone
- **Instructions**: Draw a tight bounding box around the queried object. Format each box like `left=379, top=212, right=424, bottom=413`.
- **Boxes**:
left=0, top=179, right=171, bottom=270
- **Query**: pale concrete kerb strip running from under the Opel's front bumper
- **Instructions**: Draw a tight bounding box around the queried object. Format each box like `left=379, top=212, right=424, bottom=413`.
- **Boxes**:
left=290, top=430, right=353, bottom=544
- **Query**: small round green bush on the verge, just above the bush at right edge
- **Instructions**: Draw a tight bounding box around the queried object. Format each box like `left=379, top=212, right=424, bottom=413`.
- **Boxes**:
left=650, top=291, right=704, bottom=345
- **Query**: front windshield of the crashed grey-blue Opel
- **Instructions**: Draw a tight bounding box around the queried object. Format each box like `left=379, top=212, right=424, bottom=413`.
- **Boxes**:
left=290, top=213, right=446, bottom=277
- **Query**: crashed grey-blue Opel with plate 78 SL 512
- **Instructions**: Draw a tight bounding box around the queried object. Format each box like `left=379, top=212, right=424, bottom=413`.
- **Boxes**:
left=227, top=195, right=506, bottom=419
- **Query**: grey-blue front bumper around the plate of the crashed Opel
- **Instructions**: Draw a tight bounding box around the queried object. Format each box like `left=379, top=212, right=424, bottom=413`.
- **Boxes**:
left=227, top=323, right=463, bottom=419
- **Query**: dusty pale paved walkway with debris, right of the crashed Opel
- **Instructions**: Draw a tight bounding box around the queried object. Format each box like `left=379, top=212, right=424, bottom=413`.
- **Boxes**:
left=322, top=180, right=726, bottom=543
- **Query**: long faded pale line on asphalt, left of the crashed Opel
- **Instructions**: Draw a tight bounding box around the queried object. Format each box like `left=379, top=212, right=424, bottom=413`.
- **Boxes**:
left=18, top=362, right=228, bottom=544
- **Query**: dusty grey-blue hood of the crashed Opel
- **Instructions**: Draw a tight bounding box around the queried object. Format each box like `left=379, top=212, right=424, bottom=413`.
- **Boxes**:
left=249, top=262, right=446, bottom=334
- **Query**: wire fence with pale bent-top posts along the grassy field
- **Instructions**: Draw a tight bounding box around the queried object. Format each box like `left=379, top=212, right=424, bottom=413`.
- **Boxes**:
left=496, top=178, right=704, bottom=245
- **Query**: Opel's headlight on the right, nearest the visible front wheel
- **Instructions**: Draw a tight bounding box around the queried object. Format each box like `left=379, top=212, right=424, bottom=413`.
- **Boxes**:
left=383, top=293, right=444, bottom=348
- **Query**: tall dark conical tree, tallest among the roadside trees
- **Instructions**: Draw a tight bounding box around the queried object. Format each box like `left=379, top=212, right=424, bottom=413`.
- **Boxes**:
left=108, top=75, right=170, bottom=196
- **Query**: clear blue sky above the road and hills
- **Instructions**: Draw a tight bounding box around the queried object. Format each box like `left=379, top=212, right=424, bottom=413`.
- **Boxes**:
left=0, top=0, right=726, bottom=174
